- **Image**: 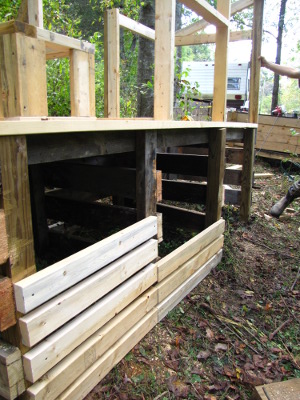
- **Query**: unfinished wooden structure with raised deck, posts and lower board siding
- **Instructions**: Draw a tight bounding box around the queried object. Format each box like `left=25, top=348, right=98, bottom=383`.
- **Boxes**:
left=0, top=0, right=260, bottom=400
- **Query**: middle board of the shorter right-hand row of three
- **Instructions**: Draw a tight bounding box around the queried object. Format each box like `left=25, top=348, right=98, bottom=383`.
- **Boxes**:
left=156, top=236, right=224, bottom=303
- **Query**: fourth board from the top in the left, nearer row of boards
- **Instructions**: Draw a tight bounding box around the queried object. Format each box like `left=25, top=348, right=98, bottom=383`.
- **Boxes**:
left=27, top=288, right=157, bottom=400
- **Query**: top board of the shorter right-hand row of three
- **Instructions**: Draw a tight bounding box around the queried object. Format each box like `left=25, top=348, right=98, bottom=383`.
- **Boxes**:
left=157, top=219, right=225, bottom=282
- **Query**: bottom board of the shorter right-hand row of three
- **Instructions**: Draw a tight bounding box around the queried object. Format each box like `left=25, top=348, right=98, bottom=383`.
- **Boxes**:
left=157, top=250, right=222, bottom=321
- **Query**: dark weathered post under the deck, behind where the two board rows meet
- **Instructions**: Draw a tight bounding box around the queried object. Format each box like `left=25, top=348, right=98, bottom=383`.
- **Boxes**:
left=136, top=131, right=157, bottom=221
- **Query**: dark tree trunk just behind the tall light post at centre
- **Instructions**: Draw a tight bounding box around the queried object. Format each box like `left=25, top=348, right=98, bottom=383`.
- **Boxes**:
left=137, top=0, right=155, bottom=117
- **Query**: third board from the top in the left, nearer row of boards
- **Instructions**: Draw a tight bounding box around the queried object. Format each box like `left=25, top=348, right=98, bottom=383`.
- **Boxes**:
left=23, top=264, right=157, bottom=382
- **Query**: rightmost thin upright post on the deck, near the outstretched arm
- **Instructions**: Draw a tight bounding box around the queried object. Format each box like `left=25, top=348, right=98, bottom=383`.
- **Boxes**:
left=249, top=0, right=264, bottom=123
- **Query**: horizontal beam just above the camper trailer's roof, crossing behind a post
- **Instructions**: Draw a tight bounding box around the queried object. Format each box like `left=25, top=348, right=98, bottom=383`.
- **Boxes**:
left=175, top=30, right=252, bottom=46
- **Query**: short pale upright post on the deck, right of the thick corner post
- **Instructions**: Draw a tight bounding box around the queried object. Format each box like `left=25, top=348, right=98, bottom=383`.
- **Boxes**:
left=70, top=50, right=95, bottom=117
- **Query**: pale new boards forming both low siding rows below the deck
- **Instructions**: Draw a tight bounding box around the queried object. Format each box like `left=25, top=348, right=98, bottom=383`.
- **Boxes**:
left=8, top=217, right=225, bottom=400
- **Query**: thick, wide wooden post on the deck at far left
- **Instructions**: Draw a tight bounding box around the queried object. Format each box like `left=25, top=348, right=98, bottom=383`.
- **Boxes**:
left=0, top=33, right=48, bottom=118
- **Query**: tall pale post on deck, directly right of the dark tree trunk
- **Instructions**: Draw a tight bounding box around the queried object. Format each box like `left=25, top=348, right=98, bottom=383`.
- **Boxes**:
left=154, top=0, right=175, bottom=120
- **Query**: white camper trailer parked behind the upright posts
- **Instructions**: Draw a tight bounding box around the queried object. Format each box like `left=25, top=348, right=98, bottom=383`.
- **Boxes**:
left=182, top=61, right=249, bottom=109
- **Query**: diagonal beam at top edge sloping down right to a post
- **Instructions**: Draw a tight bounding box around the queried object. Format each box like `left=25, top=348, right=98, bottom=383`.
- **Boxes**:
left=180, top=0, right=229, bottom=27
